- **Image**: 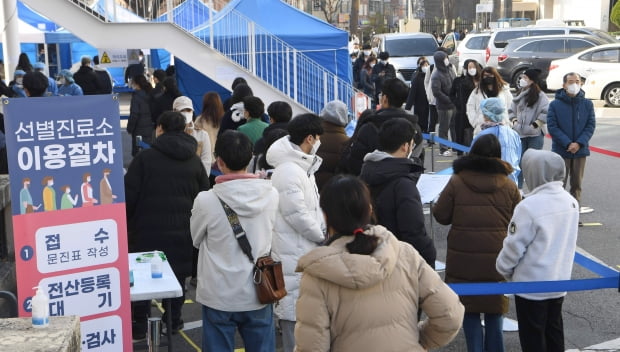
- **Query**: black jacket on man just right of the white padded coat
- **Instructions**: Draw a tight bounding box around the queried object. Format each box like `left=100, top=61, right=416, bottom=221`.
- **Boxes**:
left=360, top=151, right=437, bottom=267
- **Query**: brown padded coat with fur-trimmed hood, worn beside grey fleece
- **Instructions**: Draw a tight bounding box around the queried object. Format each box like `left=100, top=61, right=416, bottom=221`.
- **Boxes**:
left=433, top=155, right=521, bottom=314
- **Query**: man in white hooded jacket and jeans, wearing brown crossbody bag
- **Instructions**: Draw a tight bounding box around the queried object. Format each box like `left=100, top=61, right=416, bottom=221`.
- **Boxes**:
left=190, top=131, right=278, bottom=352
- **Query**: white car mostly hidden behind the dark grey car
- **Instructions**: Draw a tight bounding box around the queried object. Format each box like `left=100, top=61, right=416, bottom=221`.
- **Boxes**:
left=485, top=26, right=618, bottom=67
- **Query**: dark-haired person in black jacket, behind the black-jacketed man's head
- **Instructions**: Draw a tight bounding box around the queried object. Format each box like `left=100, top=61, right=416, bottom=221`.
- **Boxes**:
left=343, top=78, right=423, bottom=175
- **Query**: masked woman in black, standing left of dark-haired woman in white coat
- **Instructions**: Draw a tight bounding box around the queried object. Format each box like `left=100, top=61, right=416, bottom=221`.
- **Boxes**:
left=450, top=59, right=482, bottom=156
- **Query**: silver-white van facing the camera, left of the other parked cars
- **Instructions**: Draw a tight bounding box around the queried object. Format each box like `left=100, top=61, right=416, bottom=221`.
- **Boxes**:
left=370, top=33, right=439, bottom=84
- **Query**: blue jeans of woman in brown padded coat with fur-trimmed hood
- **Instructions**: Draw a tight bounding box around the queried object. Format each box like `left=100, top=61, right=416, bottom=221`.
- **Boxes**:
left=463, top=313, right=504, bottom=352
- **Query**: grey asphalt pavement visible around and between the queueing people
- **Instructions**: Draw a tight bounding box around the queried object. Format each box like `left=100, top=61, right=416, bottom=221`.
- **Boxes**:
left=121, top=99, right=620, bottom=352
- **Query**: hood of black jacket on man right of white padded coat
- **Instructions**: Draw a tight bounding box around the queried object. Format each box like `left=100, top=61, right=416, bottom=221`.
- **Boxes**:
left=360, top=150, right=424, bottom=187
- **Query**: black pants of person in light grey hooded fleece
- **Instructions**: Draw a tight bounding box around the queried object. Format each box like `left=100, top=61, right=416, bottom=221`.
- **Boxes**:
left=515, top=296, right=564, bottom=352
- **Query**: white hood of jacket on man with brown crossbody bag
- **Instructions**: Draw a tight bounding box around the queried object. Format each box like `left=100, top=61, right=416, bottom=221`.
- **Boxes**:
left=213, top=178, right=274, bottom=218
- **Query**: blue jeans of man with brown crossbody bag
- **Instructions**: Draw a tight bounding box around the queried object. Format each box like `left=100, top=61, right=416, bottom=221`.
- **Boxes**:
left=202, top=304, right=276, bottom=352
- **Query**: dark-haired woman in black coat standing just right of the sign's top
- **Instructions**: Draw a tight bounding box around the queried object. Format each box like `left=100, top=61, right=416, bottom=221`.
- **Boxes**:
left=127, top=75, right=154, bottom=156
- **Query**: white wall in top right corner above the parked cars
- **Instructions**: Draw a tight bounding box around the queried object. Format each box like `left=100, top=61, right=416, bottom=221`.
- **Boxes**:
left=553, top=0, right=609, bottom=31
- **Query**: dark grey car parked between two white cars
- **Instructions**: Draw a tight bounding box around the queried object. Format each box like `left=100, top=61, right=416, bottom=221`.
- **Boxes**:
left=497, top=34, right=605, bottom=87
